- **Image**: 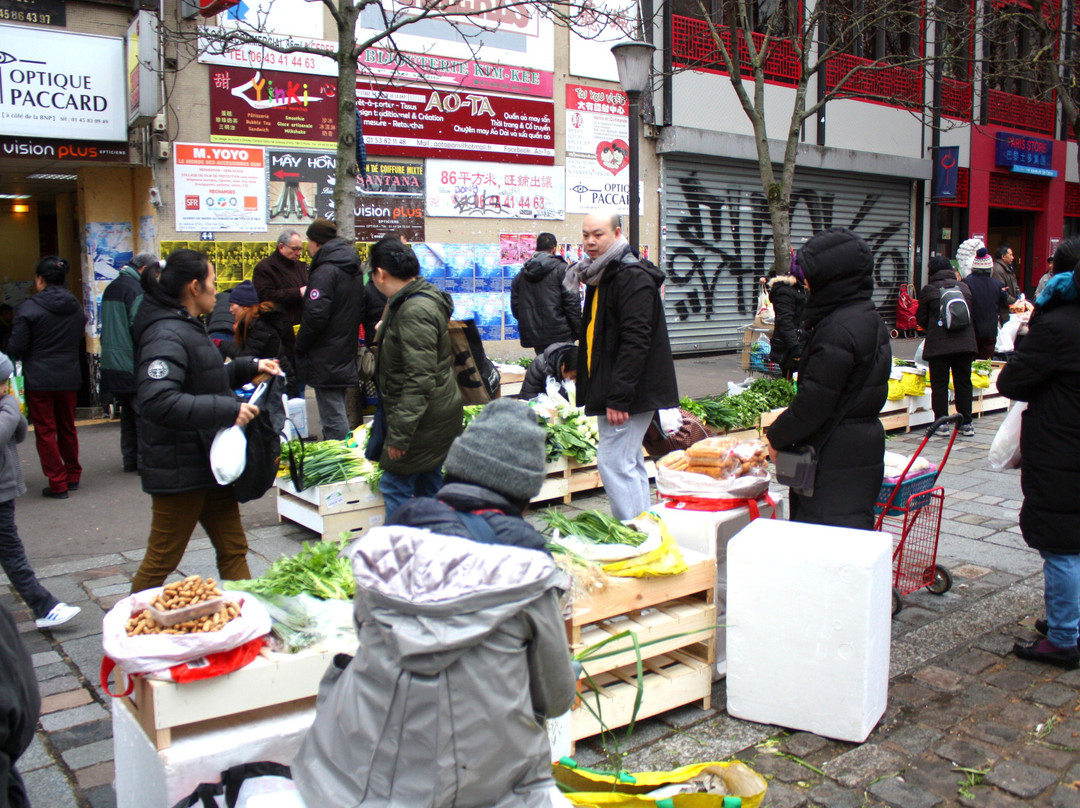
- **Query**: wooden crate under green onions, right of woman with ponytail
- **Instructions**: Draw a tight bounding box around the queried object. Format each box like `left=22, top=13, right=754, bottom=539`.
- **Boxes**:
left=275, top=477, right=386, bottom=541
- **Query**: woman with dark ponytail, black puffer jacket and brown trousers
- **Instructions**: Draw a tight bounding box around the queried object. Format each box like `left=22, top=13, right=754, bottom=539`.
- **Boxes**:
left=132, top=250, right=280, bottom=592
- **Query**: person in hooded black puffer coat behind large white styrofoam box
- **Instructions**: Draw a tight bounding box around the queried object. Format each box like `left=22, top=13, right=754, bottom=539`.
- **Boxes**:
left=768, top=228, right=892, bottom=530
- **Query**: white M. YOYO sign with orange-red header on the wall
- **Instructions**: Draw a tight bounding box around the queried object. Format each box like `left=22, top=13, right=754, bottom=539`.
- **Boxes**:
left=173, top=143, right=267, bottom=232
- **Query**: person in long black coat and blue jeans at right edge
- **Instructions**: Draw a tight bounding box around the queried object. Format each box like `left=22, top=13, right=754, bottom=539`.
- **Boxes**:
left=998, top=238, right=1080, bottom=668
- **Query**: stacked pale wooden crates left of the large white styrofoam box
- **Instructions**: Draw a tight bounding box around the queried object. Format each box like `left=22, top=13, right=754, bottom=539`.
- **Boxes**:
left=567, top=551, right=716, bottom=741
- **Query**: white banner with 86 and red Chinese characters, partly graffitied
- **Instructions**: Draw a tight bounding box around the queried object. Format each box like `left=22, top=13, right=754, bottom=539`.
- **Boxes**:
left=427, top=160, right=566, bottom=220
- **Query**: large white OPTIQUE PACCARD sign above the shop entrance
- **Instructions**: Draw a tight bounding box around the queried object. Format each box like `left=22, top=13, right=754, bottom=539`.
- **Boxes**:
left=0, top=25, right=127, bottom=142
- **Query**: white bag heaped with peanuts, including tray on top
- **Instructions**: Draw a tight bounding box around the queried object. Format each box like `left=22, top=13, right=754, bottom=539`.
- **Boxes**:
left=102, top=576, right=270, bottom=674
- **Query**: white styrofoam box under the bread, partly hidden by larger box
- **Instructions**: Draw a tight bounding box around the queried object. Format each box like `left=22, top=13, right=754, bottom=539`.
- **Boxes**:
left=652, top=495, right=784, bottom=678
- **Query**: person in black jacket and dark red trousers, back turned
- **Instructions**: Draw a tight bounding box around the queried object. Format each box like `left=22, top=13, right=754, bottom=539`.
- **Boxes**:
left=8, top=255, right=86, bottom=499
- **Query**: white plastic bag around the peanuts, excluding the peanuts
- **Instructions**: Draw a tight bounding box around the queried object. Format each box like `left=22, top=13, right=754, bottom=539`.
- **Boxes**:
left=102, top=587, right=270, bottom=674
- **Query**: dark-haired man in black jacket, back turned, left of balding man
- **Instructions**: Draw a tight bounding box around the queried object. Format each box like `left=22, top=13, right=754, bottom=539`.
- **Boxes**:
left=510, top=233, right=581, bottom=349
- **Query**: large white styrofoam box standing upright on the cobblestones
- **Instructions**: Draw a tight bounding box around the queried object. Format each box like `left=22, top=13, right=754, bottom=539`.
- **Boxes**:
left=727, top=519, right=892, bottom=743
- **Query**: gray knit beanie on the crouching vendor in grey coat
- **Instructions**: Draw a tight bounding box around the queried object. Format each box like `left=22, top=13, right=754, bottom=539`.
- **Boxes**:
left=443, top=399, right=545, bottom=500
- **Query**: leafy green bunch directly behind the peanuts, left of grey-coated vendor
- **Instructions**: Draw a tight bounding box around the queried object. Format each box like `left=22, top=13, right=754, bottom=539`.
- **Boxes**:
left=222, top=541, right=356, bottom=601
